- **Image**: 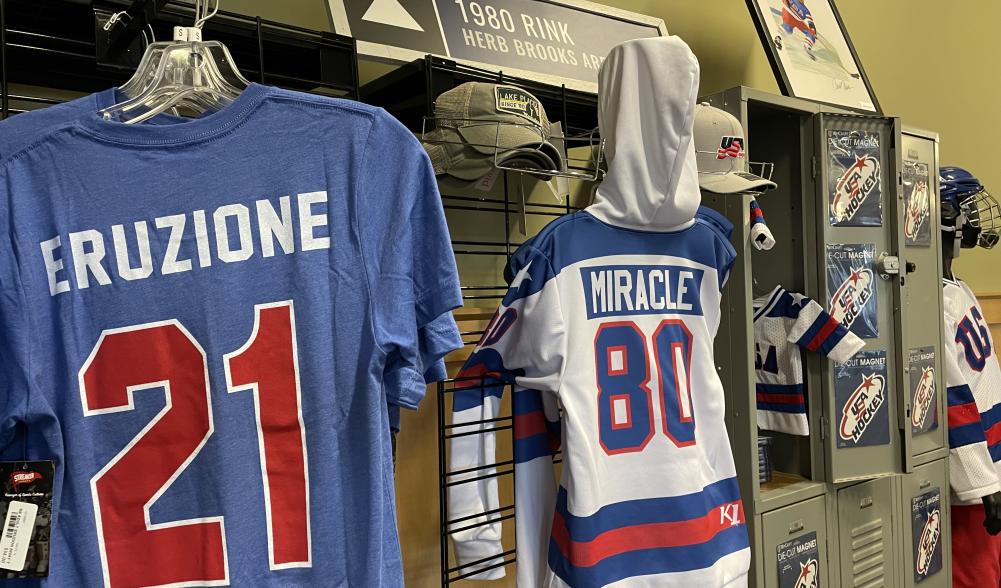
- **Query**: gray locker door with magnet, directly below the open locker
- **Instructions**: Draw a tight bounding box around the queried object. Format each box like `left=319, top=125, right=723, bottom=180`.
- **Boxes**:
left=761, top=496, right=831, bottom=588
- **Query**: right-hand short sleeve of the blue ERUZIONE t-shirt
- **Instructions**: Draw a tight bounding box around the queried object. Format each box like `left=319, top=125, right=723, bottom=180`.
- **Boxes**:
left=353, top=110, right=461, bottom=409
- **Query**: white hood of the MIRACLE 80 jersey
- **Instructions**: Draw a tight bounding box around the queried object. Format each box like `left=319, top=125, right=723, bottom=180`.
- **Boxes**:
left=588, top=36, right=702, bottom=230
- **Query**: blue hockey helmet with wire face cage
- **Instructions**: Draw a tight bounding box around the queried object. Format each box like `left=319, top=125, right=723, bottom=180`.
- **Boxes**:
left=939, top=167, right=1001, bottom=249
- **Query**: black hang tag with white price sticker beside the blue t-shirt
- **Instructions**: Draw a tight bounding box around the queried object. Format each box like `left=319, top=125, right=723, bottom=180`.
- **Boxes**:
left=0, top=461, right=55, bottom=578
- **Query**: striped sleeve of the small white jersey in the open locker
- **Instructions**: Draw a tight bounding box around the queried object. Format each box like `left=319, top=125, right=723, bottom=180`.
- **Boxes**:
left=773, top=290, right=866, bottom=362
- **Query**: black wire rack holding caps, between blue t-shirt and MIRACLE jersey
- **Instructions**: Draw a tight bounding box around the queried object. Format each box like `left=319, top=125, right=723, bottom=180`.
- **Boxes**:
left=361, top=56, right=604, bottom=586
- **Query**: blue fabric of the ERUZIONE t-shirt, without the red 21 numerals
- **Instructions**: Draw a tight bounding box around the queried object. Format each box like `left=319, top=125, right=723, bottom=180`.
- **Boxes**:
left=0, top=85, right=460, bottom=587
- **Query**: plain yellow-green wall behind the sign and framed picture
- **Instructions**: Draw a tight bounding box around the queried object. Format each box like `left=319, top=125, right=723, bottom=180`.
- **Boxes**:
left=223, top=0, right=1001, bottom=291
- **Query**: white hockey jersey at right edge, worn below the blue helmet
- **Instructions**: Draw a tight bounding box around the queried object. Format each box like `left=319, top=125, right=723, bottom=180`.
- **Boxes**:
left=942, top=278, right=1001, bottom=504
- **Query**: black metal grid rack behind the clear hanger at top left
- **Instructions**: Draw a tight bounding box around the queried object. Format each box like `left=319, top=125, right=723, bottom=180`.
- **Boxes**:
left=0, top=0, right=358, bottom=118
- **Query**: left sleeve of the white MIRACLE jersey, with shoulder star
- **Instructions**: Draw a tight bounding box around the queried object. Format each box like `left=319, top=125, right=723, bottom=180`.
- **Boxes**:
left=448, top=246, right=567, bottom=579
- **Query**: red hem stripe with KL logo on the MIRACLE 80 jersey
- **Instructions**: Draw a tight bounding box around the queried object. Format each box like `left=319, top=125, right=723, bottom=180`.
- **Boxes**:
left=553, top=500, right=744, bottom=567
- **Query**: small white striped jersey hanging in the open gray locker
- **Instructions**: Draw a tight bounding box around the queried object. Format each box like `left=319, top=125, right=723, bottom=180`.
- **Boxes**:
left=754, top=285, right=865, bottom=435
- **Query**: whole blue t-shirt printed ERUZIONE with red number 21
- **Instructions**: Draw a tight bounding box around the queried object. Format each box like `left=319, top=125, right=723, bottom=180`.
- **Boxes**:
left=0, top=84, right=460, bottom=586
